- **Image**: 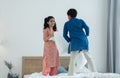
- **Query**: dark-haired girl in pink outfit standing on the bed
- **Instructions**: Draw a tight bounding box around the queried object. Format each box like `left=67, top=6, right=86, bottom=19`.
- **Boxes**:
left=42, top=16, right=59, bottom=76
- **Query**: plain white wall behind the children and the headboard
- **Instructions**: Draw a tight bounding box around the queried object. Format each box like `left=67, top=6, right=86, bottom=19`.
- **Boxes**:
left=0, top=0, right=108, bottom=78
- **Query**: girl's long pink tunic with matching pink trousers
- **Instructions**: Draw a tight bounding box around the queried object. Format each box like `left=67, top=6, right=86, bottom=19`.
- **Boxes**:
left=42, top=28, right=59, bottom=75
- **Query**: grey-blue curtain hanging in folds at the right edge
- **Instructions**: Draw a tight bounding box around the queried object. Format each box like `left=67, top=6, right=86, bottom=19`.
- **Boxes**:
left=107, top=0, right=120, bottom=73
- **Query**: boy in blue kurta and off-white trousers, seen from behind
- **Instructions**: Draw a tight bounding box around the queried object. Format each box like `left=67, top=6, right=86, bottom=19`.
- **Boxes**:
left=63, top=8, right=96, bottom=75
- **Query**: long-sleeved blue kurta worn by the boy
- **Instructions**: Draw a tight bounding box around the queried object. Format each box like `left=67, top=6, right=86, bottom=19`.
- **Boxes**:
left=63, top=18, right=89, bottom=53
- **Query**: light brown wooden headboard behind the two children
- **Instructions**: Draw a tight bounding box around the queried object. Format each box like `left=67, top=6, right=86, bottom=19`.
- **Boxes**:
left=22, top=56, right=70, bottom=77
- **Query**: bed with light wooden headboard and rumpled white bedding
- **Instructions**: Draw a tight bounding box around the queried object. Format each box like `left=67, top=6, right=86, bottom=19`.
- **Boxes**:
left=22, top=56, right=120, bottom=78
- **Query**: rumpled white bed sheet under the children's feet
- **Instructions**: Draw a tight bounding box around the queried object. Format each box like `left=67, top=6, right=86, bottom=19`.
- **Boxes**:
left=24, top=73, right=120, bottom=78
